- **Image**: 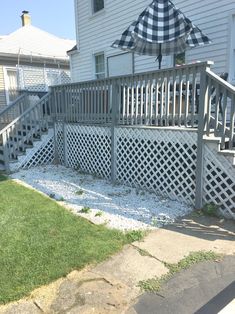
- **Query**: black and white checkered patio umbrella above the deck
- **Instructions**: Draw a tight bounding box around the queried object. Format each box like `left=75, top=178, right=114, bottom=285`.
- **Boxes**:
left=112, top=0, right=210, bottom=69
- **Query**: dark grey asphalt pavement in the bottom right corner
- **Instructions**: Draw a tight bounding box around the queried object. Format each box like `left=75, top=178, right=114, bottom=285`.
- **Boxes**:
left=134, top=256, right=235, bottom=314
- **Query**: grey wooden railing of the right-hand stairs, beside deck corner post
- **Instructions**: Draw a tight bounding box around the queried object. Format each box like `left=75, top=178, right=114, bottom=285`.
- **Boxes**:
left=205, top=69, right=235, bottom=150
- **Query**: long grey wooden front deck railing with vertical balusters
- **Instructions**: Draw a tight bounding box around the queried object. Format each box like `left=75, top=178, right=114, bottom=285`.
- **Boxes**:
left=52, top=63, right=213, bottom=127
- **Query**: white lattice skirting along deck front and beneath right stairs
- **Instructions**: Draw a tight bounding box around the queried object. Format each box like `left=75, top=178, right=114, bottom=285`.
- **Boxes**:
left=53, top=123, right=235, bottom=218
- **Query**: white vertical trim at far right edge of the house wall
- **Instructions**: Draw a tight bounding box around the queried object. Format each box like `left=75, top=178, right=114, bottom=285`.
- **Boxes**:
left=227, top=11, right=235, bottom=85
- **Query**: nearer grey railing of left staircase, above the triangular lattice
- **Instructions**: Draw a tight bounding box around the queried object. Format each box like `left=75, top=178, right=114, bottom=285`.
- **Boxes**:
left=0, top=93, right=52, bottom=171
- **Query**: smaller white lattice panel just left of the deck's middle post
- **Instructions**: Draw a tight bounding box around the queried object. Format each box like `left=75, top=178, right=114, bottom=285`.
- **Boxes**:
left=66, top=125, right=111, bottom=178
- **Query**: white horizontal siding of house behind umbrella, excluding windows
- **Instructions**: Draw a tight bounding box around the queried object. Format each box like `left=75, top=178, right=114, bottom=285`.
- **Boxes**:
left=73, top=0, right=235, bottom=81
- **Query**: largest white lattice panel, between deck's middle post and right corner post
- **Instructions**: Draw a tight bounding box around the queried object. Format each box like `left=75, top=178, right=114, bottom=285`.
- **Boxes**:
left=117, top=128, right=197, bottom=204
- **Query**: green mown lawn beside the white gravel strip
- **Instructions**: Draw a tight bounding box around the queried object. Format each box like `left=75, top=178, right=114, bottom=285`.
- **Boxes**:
left=0, top=175, right=133, bottom=303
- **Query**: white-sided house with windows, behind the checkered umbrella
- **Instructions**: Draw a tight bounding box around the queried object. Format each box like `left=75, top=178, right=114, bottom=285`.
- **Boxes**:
left=68, top=0, right=235, bottom=83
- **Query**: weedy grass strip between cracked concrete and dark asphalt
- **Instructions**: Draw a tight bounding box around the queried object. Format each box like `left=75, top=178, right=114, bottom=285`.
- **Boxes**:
left=138, top=251, right=222, bottom=292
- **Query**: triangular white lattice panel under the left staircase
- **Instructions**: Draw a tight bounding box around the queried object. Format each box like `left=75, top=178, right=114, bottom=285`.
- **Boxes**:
left=10, top=130, right=55, bottom=171
